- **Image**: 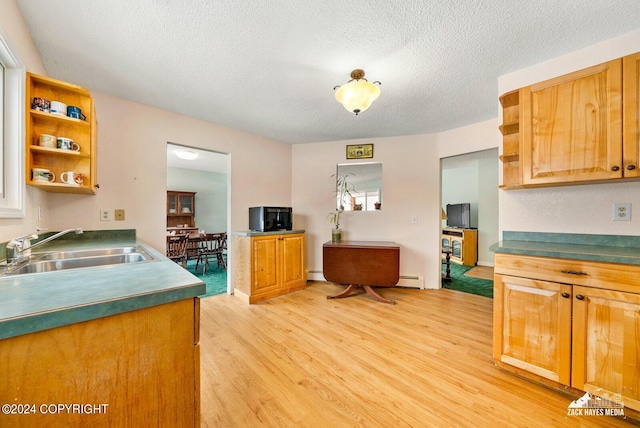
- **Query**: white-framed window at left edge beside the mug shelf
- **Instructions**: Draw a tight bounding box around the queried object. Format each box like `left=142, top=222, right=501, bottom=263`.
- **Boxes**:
left=0, top=28, right=25, bottom=218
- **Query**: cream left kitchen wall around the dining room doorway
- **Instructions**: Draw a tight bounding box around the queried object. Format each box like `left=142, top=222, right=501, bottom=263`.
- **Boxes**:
left=42, top=93, right=291, bottom=290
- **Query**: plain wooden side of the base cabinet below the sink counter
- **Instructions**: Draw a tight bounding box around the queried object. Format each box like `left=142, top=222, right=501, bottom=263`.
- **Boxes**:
left=0, top=298, right=200, bottom=427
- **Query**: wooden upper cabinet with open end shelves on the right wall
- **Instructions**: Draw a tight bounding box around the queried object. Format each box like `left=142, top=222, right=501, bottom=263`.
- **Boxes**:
left=500, top=54, right=640, bottom=189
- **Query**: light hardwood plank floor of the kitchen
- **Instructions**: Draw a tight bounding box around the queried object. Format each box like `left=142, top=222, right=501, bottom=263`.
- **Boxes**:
left=200, top=282, right=629, bottom=428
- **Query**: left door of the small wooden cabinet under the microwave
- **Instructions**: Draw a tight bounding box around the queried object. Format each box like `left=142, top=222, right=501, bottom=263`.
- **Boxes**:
left=251, top=236, right=280, bottom=295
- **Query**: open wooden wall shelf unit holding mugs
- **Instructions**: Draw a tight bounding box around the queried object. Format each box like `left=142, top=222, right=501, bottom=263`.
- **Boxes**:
left=25, top=73, right=98, bottom=194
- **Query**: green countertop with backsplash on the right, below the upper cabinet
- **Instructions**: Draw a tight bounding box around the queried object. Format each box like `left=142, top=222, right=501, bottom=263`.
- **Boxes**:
left=489, top=231, right=640, bottom=265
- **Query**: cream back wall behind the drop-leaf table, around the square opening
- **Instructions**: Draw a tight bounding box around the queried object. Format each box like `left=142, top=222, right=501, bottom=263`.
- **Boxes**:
left=292, top=135, right=440, bottom=288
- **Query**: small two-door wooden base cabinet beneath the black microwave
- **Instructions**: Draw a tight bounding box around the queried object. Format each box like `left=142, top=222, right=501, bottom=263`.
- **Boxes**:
left=235, top=233, right=307, bottom=303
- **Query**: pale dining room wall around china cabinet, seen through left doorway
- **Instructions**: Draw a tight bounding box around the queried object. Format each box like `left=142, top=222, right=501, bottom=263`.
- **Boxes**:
left=167, top=168, right=227, bottom=233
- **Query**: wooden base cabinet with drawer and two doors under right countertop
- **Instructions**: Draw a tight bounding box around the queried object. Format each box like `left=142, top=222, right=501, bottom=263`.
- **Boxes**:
left=493, top=253, right=640, bottom=411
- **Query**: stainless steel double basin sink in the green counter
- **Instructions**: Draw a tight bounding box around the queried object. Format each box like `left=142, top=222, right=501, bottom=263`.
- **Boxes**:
left=5, top=245, right=157, bottom=275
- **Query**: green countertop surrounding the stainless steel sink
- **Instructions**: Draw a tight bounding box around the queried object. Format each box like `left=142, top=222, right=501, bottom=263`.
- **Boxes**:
left=0, top=231, right=206, bottom=339
